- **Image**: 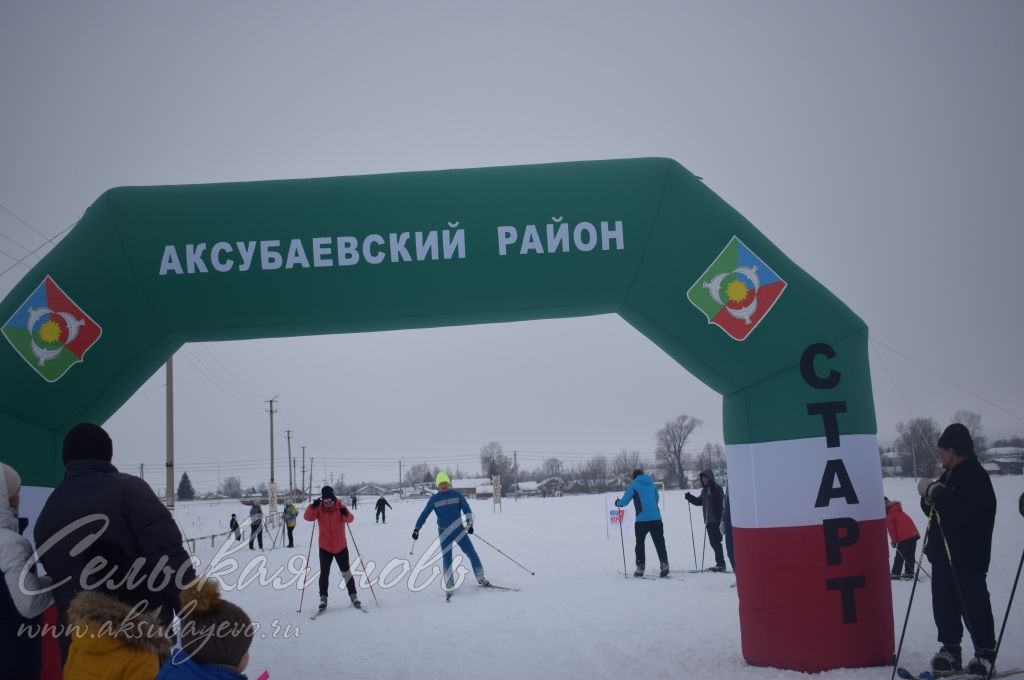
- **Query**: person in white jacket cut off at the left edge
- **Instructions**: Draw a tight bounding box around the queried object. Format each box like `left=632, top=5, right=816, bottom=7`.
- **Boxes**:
left=0, top=463, right=53, bottom=678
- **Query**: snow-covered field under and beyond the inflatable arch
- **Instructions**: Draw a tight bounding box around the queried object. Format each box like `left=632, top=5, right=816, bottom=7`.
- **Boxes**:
left=175, top=476, right=1024, bottom=680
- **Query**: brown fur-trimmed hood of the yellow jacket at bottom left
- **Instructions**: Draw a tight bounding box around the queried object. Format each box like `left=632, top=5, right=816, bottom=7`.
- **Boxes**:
left=68, top=590, right=171, bottom=657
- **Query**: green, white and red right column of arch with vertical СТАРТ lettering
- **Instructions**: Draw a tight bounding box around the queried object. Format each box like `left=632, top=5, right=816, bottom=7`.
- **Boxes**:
left=725, top=334, right=893, bottom=672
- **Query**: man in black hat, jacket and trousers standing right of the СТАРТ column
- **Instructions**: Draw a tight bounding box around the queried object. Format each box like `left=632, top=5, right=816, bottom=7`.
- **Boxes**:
left=918, top=423, right=995, bottom=676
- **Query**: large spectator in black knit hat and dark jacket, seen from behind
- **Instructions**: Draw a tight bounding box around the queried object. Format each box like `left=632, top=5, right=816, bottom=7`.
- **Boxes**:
left=35, top=423, right=196, bottom=657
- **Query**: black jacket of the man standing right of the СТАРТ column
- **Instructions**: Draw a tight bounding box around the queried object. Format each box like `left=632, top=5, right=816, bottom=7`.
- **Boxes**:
left=921, top=455, right=995, bottom=572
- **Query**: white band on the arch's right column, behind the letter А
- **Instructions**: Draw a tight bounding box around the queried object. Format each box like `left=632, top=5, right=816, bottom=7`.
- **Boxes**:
left=725, top=434, right=886, bottom=528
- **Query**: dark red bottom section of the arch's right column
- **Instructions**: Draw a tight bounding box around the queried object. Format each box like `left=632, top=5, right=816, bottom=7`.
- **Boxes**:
left=732, top=519, right=894, bottom=673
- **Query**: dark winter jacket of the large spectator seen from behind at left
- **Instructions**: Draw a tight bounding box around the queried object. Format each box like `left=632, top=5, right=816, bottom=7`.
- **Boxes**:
left=35, top=460, right=196, bottom=634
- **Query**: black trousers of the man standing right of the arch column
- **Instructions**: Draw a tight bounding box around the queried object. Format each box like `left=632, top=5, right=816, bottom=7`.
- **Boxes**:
left=932, top=557, right=995, bottom=650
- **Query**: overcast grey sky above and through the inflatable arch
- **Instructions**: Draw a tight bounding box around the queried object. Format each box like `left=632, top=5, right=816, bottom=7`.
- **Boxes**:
left=0, top=0, right=1024, bottom=490
